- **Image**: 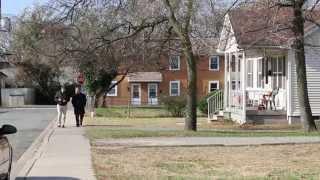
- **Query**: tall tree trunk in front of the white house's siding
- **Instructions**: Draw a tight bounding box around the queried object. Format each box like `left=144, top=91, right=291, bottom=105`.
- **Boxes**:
left=292, top=0, right=317, bottom=132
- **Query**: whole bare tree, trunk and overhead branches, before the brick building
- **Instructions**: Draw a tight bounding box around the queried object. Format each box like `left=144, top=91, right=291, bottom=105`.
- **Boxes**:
left=46, top=0, right=226, bottom=131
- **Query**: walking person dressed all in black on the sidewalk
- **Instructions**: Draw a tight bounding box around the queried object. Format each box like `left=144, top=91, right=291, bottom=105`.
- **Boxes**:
left=72, top=87, right=87, bottom=127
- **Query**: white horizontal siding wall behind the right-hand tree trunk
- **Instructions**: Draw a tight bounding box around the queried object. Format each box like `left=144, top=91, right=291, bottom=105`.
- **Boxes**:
left=289, top=31, right=320, bottom=116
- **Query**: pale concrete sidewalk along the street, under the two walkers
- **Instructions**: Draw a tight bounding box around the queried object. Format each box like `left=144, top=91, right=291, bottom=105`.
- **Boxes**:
left=16, top=111, right=96, bottom=180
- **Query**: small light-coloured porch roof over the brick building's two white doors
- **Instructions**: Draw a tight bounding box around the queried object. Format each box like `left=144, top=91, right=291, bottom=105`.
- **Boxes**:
left=128, top=72, right=162, bottom=82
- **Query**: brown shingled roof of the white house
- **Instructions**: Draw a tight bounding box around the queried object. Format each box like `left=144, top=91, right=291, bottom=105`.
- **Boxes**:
left=229, top=8, right=320, bottom=47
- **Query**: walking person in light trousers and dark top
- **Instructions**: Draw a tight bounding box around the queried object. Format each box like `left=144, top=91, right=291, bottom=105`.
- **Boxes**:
left=54, top=86, right=70, bottom=128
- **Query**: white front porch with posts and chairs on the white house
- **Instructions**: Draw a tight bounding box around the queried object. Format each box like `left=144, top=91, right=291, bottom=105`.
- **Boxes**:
left=224, top=50, right=288, bottom=124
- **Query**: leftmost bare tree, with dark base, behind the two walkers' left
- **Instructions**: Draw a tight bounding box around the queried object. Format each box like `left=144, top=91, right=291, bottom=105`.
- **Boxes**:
left=8, top=7, right=63, bottom=103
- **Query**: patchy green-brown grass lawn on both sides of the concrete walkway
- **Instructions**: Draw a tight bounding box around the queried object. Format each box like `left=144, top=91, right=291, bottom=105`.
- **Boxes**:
left=85, top=108, right=320, bottom=180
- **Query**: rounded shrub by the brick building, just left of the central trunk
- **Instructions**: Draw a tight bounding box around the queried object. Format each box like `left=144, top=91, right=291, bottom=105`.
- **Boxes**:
left=161, top=95, right=187, bottom=117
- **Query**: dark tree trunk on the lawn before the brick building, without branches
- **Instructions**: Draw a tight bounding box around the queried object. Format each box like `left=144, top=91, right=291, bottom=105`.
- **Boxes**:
left=184, top=38, right=197, bottom=131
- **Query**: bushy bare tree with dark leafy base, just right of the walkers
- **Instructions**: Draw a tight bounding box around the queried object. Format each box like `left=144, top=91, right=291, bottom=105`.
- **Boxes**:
left=48, top=1, right=166, bottom=109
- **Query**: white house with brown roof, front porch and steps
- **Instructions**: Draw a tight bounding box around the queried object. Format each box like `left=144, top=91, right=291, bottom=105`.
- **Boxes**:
left=208, top=8, right=320, bottom=124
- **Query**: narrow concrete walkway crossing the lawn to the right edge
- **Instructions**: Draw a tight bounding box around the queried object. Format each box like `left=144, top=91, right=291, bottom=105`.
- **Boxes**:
left=94, top=137, right=320, bottom=147
